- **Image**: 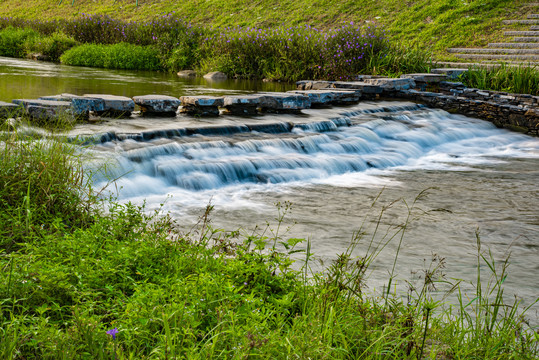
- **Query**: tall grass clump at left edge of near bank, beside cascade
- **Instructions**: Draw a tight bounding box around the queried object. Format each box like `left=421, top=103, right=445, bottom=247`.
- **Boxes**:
left=0, top=124, right=91, bottom=253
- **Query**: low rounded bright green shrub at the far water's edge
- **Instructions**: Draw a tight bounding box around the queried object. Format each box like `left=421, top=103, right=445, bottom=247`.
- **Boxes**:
left=60, top=43, right=161, bottom=70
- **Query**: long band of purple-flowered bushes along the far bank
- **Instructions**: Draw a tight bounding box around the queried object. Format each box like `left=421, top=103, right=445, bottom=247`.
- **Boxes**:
left=0, top=14, right=430, bottom=81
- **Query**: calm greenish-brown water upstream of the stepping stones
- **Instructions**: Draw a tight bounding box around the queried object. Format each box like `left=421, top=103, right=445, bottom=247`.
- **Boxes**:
left=0, top=57, right=294, bottom=102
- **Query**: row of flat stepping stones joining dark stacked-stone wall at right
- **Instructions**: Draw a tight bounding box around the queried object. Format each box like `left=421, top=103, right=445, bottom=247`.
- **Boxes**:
left=0, top=69, right=539, bottom=136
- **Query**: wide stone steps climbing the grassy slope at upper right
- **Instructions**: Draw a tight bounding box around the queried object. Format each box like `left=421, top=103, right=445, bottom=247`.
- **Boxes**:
left=438, top=2, right=539, bottom=67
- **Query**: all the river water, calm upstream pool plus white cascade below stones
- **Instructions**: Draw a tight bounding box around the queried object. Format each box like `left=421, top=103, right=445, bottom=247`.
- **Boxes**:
left=5, top=58, right=539, bottom=318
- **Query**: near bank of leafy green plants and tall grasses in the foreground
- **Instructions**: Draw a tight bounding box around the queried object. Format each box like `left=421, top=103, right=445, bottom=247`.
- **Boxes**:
left=0, top=121, right=539, bottom=359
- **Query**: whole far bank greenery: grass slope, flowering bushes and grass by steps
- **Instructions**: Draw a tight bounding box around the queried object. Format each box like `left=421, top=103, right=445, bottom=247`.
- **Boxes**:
left=0, top=0, right=539, bottom=95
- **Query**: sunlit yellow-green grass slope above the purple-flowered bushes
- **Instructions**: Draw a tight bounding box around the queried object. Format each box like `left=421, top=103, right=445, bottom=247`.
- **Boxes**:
left=0, top=0, right=533, bottom=58
